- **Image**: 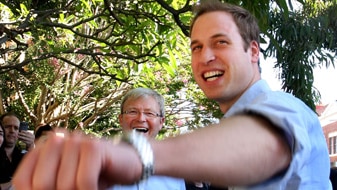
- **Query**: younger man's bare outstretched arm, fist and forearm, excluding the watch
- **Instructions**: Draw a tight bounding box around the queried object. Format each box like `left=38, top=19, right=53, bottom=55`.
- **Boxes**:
left=13, top=115, right=291, bottom=190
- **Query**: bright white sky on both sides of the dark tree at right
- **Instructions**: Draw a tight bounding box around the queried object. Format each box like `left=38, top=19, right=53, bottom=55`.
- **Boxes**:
left=261, top=58, right=337, bottom=105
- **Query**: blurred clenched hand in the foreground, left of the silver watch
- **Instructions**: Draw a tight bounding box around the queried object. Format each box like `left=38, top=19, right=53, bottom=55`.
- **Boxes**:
left=13, top=132, right=142, bottom=190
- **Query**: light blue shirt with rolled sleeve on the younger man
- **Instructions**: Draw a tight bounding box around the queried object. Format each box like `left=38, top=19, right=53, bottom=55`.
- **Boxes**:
left=224, top=80, right=332, bottom=190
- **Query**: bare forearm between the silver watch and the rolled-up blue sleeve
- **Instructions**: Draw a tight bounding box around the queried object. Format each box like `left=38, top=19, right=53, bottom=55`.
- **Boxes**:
left=153, top=115, right=291, bottom=186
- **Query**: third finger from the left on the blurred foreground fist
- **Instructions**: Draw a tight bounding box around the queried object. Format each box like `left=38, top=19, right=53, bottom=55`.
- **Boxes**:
left=56, top=132, right=81, bottom=190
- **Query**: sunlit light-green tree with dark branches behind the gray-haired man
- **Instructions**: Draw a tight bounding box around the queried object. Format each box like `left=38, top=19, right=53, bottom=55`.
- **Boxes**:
left=0, top=1, right=203, bottom=137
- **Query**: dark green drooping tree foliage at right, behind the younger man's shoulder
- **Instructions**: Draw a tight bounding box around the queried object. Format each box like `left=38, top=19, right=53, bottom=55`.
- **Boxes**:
left=265, top=1, right=337, bottom=111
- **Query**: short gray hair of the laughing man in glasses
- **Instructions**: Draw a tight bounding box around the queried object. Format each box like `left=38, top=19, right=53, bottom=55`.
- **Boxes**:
left=120, top=88, right=165, bottom=117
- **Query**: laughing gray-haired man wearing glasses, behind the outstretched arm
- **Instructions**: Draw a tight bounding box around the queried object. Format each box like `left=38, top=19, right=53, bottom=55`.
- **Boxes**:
left=109, top=88, right=185, bottom=190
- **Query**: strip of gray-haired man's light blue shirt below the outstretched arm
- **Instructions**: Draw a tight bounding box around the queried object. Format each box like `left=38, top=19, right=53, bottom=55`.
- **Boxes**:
left=108, top=176, right=185, bottom=190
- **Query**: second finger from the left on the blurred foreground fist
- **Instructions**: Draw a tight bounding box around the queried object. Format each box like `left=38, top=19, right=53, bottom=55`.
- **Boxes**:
left=32, top=135, right=65, bottom=190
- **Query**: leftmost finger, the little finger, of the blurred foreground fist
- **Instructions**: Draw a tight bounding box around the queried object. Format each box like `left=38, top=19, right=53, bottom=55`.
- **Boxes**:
left=13, top=145, right=40, bottom=190
